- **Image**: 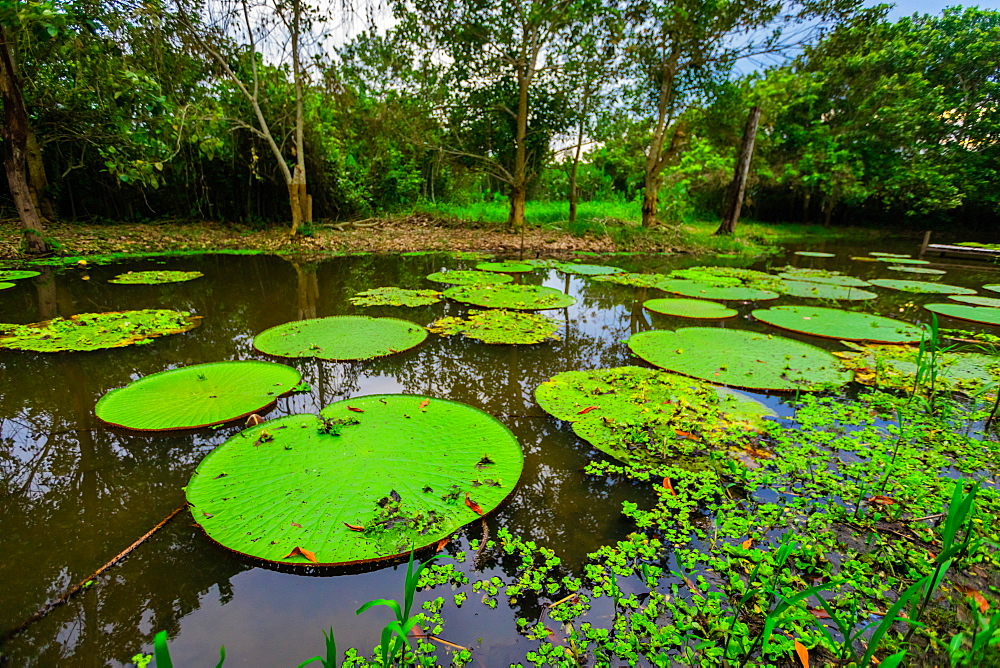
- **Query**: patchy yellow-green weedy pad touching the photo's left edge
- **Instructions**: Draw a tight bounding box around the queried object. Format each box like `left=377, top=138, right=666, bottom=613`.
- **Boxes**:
left=0, top=309, right=201, bottom=353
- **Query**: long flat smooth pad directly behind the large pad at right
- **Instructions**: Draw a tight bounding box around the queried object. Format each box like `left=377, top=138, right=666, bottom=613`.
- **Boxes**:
left=752, top=306, right=924, bottom=343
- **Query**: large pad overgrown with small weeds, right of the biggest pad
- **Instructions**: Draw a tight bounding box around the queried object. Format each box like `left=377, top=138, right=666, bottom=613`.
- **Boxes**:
left=535, top=366, right=773, bottom=464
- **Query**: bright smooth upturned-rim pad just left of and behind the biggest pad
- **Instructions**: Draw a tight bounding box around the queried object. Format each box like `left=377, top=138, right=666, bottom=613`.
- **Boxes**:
left=94, top=361, right=302, bottom=431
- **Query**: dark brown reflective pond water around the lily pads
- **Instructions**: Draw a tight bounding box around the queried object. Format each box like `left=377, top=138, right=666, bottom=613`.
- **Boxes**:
left=0, top=243, right=1000, bottom=666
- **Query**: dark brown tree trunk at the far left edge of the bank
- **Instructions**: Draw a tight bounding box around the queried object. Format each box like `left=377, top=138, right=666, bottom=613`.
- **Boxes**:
left=0, top=27, right=49, bottom=255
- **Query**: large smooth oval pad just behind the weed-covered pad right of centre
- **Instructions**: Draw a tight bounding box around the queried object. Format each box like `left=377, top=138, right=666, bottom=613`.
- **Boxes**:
left=628, top=327, right=851, bottom=390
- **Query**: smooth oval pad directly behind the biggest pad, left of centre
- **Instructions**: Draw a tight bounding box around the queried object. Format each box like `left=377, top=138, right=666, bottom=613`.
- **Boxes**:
left=253, top=315, right=427, bottom=360
